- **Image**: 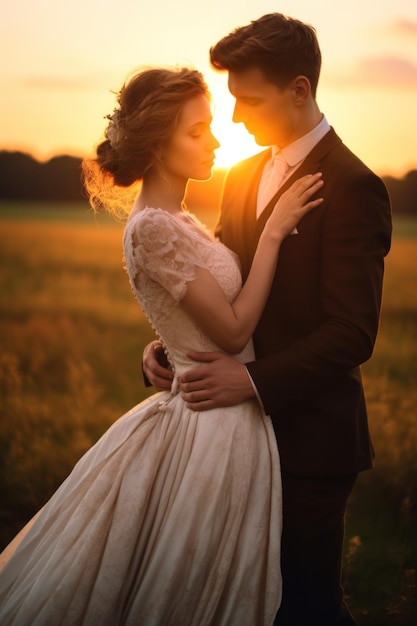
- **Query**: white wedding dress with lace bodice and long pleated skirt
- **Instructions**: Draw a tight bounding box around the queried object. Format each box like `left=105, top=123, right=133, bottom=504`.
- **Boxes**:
left=0, top=208, right=281, bottom=626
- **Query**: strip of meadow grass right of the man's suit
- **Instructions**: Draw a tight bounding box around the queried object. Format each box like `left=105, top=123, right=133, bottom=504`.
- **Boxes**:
left=344, top=233, right=417, bottom=626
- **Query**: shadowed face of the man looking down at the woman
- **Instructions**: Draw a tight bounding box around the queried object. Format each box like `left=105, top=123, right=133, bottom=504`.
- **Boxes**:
left=228, top=67, right=298, bottom=148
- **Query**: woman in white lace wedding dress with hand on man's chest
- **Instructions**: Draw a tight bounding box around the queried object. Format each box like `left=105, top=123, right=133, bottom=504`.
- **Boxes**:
left=0, top=69, right=321, bottom=626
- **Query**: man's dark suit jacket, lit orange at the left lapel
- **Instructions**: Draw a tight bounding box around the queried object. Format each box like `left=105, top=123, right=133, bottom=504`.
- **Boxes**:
left=218, top=129, right=391, bottom=477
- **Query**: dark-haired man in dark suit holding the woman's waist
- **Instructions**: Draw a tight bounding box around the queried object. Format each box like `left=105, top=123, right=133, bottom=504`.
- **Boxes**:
left=144, top=13, right=391, bottom=626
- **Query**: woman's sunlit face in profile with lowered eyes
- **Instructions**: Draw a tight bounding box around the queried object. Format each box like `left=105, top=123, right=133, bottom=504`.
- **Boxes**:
left=161, top=95, right=220, bottom=180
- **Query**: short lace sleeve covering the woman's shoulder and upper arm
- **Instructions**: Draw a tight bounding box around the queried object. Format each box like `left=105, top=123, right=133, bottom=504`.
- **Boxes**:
left=131, top=209, right=206, bottom=301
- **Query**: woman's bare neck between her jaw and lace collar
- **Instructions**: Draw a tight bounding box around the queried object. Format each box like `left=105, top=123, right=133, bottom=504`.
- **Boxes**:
left=136, top=173, right=187, bottom=213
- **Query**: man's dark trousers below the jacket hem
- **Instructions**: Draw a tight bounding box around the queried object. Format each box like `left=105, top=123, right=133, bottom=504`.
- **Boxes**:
left=275, top=471, right=356, bottom=626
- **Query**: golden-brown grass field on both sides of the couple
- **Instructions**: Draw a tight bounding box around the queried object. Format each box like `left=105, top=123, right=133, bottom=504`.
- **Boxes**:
left=0, top=205, right=417, bottom=626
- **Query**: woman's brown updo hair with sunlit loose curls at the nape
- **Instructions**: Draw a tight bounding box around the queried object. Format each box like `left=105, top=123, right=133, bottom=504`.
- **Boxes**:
left=82, top=68, right=209, bottom=215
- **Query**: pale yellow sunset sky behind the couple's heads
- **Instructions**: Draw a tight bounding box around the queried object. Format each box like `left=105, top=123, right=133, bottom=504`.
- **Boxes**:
left=0, top=0, right=417, bottom=176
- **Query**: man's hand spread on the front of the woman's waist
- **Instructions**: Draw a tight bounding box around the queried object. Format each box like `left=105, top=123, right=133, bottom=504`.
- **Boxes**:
left=180, top=352, right=255, bottom=411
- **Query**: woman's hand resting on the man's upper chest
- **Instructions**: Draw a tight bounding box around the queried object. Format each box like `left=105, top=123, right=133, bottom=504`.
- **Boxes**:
left=264, top=173, right=323, bottom=242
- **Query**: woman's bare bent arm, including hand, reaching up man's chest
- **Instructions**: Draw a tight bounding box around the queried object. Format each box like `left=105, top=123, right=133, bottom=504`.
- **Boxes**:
left=181, top=174, right=323, bottom=354
